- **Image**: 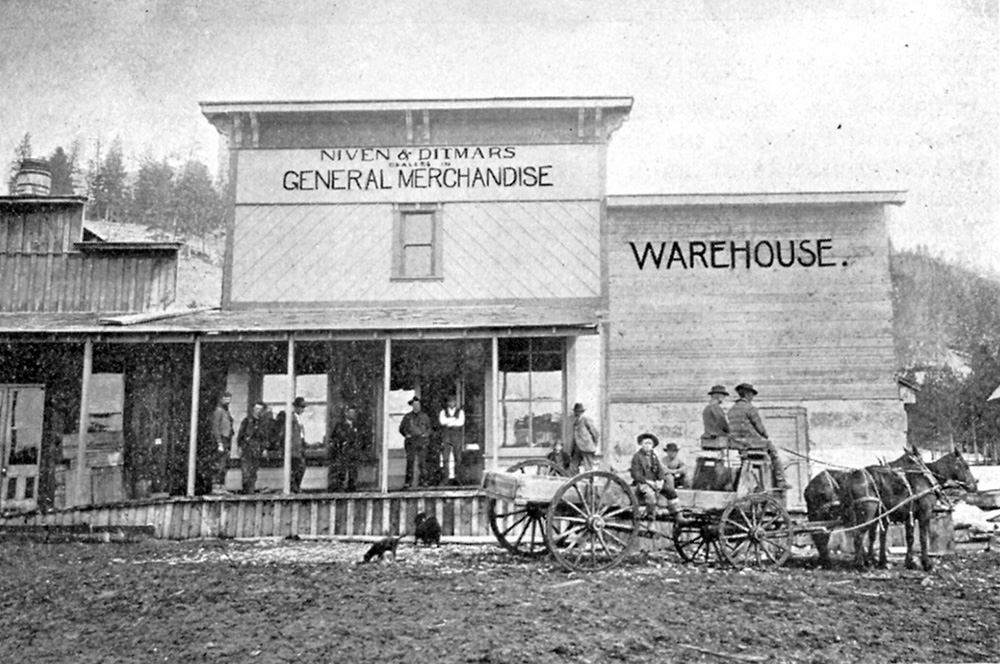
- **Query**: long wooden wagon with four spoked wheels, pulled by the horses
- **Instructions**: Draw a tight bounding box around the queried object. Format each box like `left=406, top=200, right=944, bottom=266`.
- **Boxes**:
left=483, top=454, right=794, bottom=571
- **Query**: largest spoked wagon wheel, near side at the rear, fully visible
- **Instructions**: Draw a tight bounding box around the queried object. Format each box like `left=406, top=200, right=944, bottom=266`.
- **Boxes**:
left=545, top=470, right=639, bottom=572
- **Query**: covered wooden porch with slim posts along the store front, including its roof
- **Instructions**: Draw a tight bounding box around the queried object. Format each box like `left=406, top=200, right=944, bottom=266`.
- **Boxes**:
left=0, top=302, right=603, bottom=520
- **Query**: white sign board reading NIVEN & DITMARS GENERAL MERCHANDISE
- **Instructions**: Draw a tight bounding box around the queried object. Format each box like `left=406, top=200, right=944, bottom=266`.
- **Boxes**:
left=236, top=144, right=603, bottom=204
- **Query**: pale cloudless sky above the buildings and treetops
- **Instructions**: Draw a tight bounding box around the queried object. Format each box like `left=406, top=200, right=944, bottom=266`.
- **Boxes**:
left=0, top=0, right=1000, bottom=279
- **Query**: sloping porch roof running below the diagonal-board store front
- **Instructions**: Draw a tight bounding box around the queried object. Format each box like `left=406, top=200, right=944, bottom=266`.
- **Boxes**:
left=0, top=300, right=599, bottom=341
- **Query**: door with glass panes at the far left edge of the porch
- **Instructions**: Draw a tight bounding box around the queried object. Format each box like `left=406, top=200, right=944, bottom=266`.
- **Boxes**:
left=0, top=385, right=45, bottom=511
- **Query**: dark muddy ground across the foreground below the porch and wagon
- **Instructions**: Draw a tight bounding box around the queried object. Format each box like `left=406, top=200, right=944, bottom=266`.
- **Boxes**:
left=0, top=541, right=1000, bottom=663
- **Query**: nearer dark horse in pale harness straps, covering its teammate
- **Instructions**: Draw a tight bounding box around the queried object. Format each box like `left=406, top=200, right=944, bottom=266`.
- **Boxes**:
left=840, top=450, right=976, bottom=571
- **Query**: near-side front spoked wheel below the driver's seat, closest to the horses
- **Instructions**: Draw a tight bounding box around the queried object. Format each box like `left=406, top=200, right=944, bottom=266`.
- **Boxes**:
left=719, top=493, right=792, bottom=568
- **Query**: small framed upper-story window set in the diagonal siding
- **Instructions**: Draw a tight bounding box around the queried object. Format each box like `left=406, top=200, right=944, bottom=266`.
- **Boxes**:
left=392, top=204, right=444, bottom=279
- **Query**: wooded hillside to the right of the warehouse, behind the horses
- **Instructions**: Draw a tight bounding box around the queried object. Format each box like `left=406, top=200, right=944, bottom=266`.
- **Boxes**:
left=890, top=250, right=1000, bottom=460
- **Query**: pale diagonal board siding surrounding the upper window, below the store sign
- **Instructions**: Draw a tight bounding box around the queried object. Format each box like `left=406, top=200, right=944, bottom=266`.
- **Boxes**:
left=232, top=201, right=601, bottom=304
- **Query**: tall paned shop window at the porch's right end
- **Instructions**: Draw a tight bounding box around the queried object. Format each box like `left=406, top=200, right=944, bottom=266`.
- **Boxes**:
left=498, top=339, right=566, bottom=447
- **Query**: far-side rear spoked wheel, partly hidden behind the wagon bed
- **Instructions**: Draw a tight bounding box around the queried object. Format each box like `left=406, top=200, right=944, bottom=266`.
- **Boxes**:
left=488, top=459, right=566, bottom=558
